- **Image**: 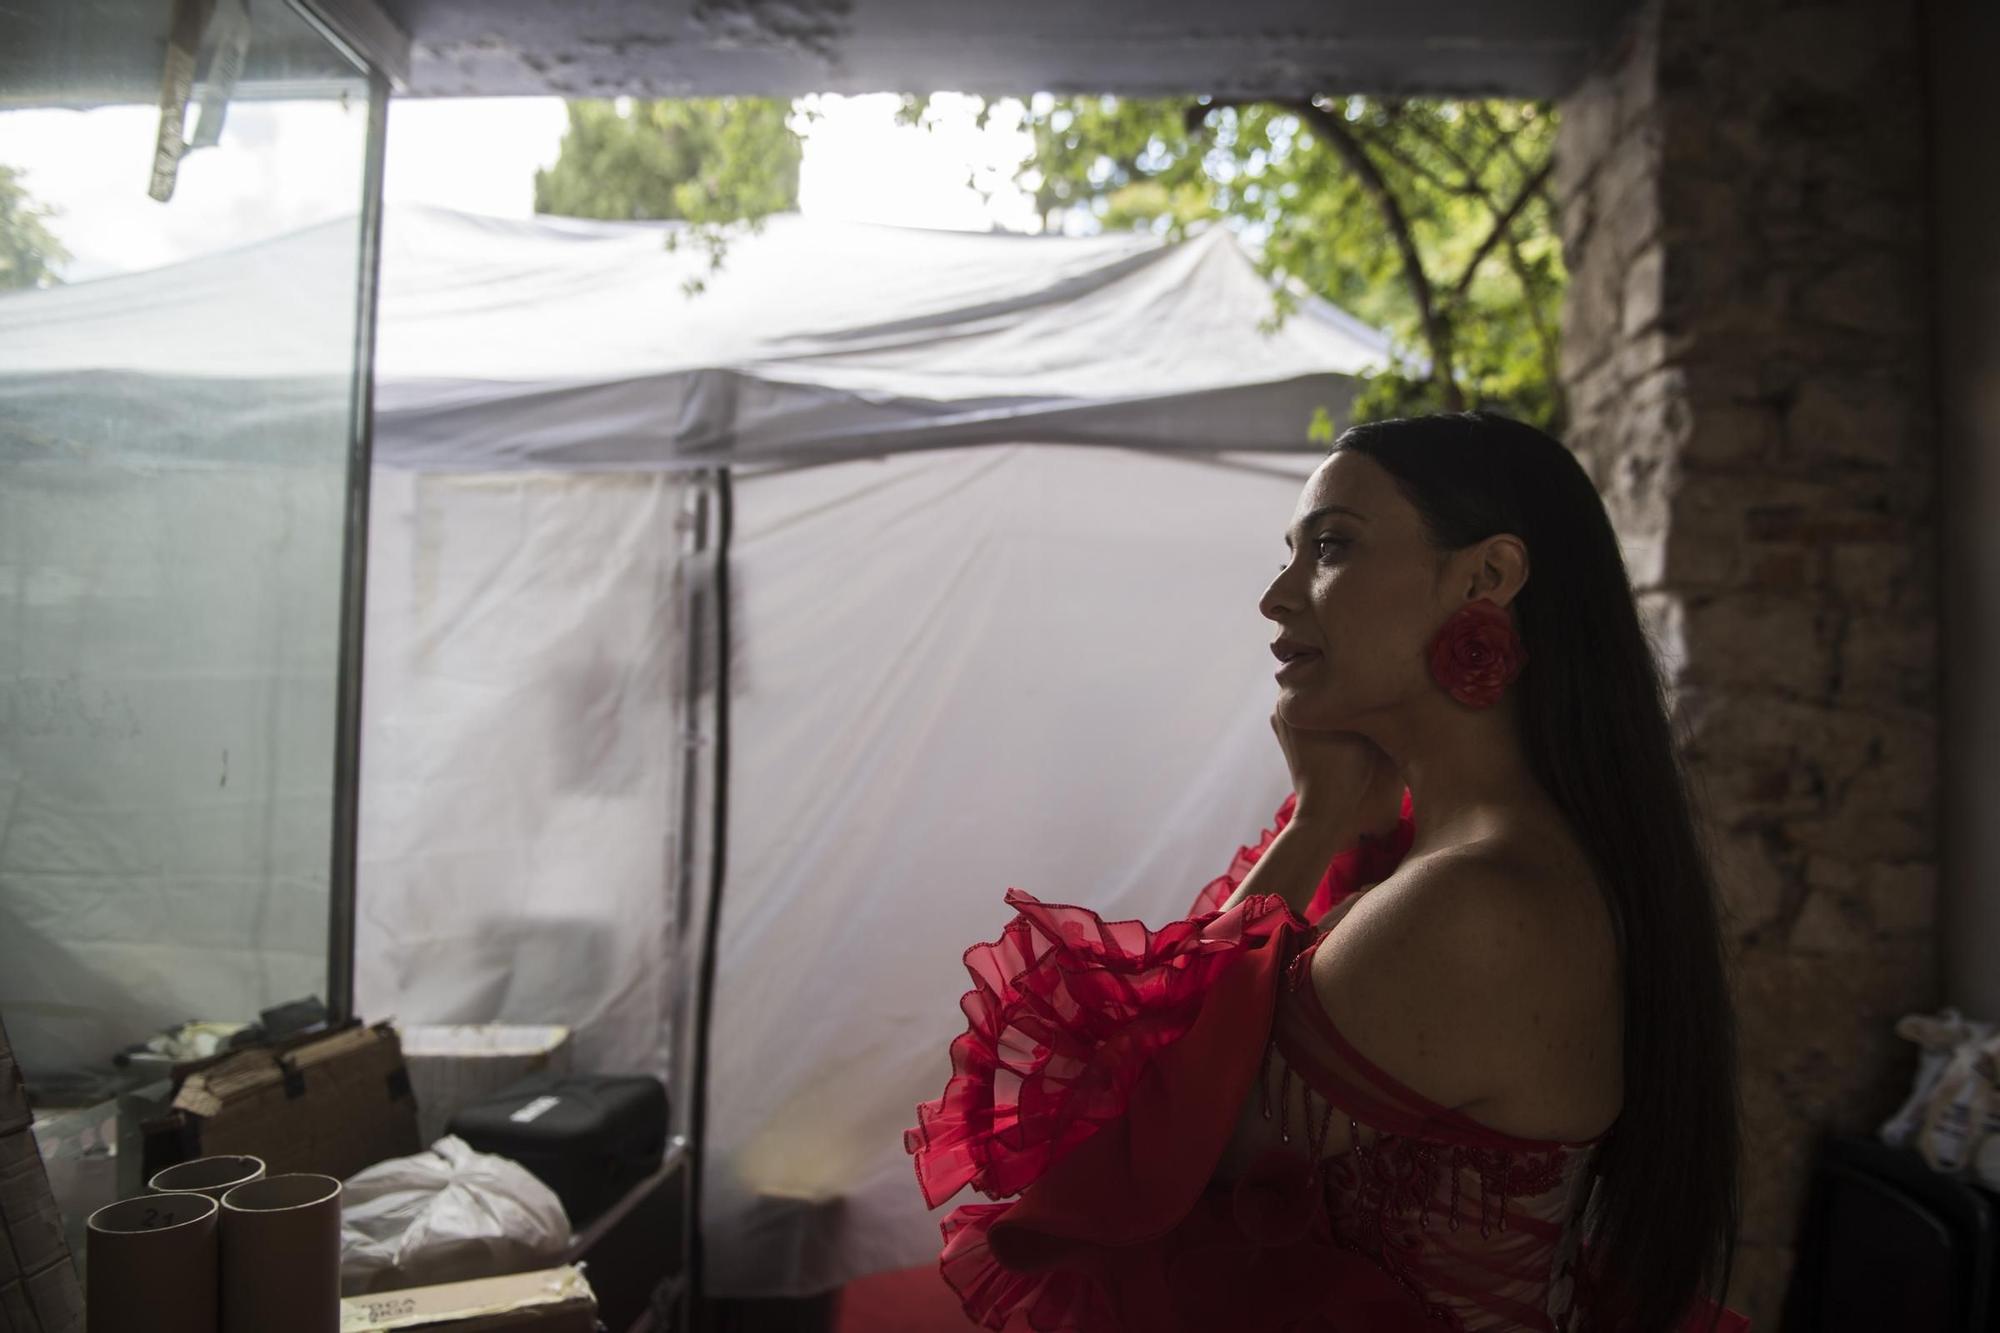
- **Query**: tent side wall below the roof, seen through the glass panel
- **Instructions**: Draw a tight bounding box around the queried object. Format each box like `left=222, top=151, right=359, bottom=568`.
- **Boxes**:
left=0, top=456, right=346, bottom=1105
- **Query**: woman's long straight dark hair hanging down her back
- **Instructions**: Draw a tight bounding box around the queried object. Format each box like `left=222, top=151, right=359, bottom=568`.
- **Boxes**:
left=1334, top=412, right=1740, bottom=1333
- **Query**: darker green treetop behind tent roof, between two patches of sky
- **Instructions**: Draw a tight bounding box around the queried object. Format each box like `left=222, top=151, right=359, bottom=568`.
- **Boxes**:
left=534, top=98, right=804, bottom=294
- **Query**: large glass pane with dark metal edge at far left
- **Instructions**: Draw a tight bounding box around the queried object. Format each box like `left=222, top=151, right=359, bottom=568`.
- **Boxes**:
left=0, top=0, right=370, bottom=1144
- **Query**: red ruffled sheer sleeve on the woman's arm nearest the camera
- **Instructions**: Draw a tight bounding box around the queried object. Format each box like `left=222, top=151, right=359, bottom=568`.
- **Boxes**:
left=904, top=889, right=1424, bottom=1333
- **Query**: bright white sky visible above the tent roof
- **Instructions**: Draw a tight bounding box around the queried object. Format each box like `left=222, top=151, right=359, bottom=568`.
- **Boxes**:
left=0, top=94, right=1038, bottom=282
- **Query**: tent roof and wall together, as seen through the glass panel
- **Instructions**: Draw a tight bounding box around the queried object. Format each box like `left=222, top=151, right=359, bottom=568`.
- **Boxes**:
left=0, top=218, right=360, bottom=1105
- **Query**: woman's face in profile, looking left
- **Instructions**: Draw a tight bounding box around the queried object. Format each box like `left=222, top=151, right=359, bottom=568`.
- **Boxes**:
left=1258, top=452, right=1452, bottom=731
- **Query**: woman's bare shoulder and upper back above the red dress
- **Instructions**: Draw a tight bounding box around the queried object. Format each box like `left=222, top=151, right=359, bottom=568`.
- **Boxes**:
left=1312, top=843, right=1618, bottom=1137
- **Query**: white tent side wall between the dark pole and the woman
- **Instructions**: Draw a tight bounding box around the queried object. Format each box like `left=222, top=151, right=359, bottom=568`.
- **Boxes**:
left=704, top=446, right=1314, bottom=1295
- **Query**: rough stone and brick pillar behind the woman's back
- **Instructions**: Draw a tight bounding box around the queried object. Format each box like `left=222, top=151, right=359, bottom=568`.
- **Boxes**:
left=1556, top=0, right=1938, bottom=1304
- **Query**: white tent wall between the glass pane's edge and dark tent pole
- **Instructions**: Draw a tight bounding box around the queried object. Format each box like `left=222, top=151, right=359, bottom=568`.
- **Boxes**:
left=354, top=470, right=682, bottom=1073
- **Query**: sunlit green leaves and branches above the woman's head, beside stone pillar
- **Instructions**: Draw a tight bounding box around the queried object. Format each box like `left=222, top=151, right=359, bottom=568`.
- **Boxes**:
left=904, top=96, right=1566, bottom=430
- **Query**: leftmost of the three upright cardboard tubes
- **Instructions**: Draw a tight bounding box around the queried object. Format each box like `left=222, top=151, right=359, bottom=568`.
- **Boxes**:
left=84, top=1195, right=218, bottom=1333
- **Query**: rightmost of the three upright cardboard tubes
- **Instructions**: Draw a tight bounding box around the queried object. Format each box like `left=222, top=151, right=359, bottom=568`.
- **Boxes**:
left=222, top=1175, right=340, bottom=1333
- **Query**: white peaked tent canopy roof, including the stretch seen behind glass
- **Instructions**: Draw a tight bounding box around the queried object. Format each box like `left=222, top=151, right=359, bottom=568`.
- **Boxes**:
left=0, top=208, right=1388, bottom=470
